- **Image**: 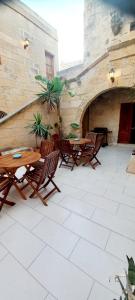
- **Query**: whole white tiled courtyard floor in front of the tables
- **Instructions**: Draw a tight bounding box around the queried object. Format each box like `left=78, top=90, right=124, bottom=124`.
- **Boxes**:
left=0, top=146, right=135, bottom=300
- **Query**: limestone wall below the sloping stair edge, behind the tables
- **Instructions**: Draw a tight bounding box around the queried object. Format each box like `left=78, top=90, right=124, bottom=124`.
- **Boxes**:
left=0, top=102, right=57, bottom=148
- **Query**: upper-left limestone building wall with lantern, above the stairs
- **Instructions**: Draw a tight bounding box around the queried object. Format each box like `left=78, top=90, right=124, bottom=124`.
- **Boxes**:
left=0, top=0, right=58, bottom=113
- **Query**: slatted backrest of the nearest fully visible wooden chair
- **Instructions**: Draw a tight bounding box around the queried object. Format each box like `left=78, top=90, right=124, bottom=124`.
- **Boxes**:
left=39, top=150, right=60, bottom=184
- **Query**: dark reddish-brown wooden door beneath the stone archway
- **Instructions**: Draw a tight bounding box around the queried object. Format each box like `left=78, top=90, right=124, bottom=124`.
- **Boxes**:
left=118, top=103, right=133, bottom=144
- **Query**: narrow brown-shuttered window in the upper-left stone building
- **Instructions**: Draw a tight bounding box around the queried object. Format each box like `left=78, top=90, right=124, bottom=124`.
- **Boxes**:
left=45, top=51, right=54, bottom=79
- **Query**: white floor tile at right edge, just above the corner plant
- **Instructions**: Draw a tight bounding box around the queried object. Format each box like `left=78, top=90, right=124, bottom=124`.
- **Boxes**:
left=106, top=233, right=135, bottom=261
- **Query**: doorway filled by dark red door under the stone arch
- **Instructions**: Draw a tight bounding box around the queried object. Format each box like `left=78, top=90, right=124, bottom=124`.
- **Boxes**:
left=118, top=103, right=135, bottom=144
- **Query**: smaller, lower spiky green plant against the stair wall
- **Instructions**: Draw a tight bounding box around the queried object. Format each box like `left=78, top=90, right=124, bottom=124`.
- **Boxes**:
left=26, top=113, right=52, bottom=147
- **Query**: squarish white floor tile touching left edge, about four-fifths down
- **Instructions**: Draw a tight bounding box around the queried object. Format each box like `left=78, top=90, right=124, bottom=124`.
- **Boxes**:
left=0, top=224, right=45, bottom=268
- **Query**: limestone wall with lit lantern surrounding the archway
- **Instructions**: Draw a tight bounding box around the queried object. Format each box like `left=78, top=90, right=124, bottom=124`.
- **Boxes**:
left=61, top=43, right=135, bottom=135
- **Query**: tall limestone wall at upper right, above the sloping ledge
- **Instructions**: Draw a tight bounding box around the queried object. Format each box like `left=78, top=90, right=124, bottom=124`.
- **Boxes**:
left=84, top=0, right=135, bottom=65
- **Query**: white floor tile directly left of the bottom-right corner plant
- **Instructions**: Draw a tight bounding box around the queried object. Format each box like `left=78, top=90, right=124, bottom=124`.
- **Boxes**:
left=70, top=240, right=126, bottom=292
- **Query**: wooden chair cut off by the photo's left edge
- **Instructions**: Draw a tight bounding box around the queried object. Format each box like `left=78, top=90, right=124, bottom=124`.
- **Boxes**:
left=0, top=176, right=15, bottom=211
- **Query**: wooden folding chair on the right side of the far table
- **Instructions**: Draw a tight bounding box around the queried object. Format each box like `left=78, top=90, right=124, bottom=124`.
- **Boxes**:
left=80, top=134, right=104, bottom=169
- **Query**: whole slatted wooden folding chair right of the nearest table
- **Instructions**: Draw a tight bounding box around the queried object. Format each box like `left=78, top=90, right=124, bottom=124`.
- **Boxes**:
left=22, top=151, right=60, bottom=205
